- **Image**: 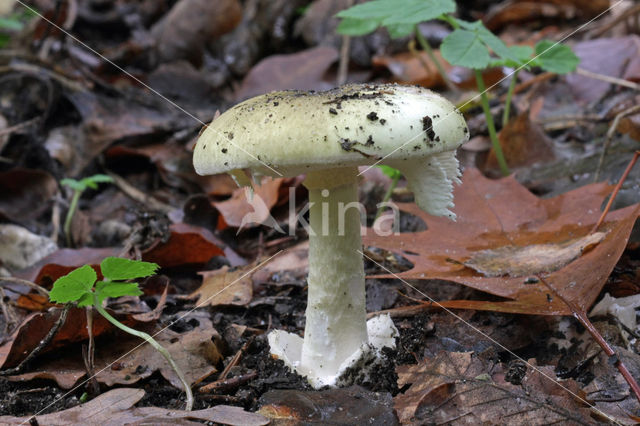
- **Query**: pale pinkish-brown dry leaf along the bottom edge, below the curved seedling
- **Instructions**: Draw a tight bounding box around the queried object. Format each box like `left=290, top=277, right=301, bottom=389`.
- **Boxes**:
left=0, top=388, right=269, bottom=426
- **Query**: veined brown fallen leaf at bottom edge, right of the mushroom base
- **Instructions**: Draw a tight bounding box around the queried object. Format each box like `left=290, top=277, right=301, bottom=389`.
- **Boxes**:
left=394, top=351, right=591, bottom=424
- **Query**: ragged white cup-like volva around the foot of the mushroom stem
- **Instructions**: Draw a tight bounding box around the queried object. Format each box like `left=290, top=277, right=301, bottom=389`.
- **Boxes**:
left=267, top=315, right=399, bottom=389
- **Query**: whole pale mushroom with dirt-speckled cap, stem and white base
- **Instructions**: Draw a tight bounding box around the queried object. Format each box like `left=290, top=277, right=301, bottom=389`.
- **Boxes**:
left=193, top=84, right=468, bottom=387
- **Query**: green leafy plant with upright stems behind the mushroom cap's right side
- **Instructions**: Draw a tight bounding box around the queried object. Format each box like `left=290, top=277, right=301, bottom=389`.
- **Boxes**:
left=336, top=0, right=579, bottom=175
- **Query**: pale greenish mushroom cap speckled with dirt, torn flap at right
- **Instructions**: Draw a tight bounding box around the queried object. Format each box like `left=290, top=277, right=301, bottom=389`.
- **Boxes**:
left=193, top=84, right=469, bottom=215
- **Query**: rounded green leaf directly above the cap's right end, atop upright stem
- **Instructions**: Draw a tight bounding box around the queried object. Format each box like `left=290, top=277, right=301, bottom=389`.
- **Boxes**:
left=440, top=29, right=491, bottom=69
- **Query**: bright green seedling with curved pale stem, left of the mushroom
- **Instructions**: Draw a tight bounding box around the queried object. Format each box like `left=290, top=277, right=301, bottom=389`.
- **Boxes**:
left=49, top=257, right=193, bottom=410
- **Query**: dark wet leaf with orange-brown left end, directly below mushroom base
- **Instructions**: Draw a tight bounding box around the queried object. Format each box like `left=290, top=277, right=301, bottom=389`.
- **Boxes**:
left=258, top=386, right=398, bottom=425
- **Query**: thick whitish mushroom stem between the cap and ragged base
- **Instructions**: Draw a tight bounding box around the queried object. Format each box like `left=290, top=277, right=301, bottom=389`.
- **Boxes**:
left=300, top=167, right=368, bottom=381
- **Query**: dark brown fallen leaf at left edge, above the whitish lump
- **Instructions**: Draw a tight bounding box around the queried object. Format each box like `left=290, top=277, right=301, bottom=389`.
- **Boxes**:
left=0, top=167, right=58, bottom=224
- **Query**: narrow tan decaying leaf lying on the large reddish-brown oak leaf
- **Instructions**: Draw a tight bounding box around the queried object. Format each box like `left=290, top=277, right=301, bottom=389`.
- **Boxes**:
left=464, top=232, right=606, bottom=277
